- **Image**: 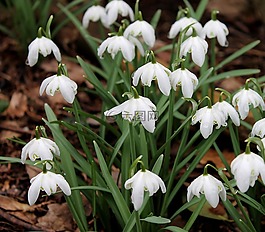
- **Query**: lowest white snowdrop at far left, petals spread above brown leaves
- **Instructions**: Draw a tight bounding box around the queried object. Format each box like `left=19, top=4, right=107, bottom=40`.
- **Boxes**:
left=28, top=171, right=71, bottom=205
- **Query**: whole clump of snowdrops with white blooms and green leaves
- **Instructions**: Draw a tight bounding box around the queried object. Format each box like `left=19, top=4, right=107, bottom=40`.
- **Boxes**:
left=2, top=0, right=265, bottom=231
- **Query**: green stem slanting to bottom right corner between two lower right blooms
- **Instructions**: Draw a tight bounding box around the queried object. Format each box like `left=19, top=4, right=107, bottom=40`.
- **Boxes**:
left=218, top=169, right=256, bottom=231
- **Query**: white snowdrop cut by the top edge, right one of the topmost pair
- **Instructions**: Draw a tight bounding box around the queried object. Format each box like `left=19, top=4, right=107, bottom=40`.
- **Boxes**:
left=105, top=0, right=134, bottom=25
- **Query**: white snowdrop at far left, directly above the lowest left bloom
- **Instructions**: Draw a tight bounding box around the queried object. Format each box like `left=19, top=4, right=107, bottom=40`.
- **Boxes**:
left=21, top=137, right=60, bottom=164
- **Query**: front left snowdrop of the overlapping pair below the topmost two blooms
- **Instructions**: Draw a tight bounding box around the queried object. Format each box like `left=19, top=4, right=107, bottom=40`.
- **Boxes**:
left=98, top=35, right=135, bottom=62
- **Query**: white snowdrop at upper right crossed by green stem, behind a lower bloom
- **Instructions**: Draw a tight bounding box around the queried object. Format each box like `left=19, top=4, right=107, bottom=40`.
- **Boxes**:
left=168, top=17, right=204, bottom=39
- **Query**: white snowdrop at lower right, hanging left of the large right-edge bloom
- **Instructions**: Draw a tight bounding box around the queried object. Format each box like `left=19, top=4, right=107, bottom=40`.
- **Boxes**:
left=187, top=174, right=226, bottom=208
